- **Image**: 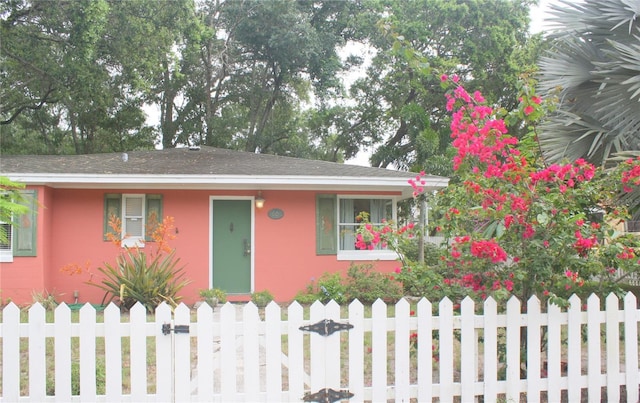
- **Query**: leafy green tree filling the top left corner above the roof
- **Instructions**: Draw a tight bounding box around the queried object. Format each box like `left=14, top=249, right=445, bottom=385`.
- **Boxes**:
left=0, top=0, right=189, bottom=153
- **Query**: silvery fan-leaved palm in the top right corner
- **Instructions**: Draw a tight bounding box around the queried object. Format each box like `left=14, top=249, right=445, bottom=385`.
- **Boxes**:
left=539, top=0, right=640, bottom=166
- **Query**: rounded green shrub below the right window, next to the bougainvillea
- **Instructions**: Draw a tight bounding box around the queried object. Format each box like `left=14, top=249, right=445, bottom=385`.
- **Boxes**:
left=345, top=264, right=403, bottom=304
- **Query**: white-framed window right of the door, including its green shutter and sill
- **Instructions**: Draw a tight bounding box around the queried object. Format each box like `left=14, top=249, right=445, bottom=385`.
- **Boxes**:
left=316, top=195, right=397, bottom=260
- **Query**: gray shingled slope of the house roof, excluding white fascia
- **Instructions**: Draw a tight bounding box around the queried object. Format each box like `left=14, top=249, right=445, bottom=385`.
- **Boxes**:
left=0, top=147, right=424, bottom=178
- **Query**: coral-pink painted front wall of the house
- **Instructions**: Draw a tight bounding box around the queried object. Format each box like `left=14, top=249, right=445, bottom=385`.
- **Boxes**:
left=0, top=187, right=398, bottom=303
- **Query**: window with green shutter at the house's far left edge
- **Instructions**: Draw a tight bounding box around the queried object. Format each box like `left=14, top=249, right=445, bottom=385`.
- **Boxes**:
left=0, top=190, right=38, bottom=263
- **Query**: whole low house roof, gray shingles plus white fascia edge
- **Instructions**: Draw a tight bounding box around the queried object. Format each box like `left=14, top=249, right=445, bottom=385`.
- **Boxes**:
left=0, top=147, right=448, bottom=195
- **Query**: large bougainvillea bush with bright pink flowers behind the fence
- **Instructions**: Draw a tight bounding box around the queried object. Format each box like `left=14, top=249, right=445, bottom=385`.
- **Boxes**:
left=360, top=76, right=640, bottom=305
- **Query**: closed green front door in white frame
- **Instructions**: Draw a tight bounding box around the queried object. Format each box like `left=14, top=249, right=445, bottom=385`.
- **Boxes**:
left=211, top=200, right=252, bottom=294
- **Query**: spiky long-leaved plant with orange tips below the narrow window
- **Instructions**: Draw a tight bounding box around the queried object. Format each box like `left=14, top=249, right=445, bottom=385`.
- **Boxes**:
left=89, top=248, right=189, bottom=312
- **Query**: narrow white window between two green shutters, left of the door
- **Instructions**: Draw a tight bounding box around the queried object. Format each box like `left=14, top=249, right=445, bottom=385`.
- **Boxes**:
left=104, top=193, right=162, bottom=247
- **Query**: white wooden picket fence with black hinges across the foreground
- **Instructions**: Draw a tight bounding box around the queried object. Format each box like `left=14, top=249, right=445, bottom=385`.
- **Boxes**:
left=0, top=294, right=640, bottom=402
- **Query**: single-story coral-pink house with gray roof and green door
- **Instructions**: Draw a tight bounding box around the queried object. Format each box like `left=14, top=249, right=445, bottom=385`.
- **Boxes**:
left=0, top=147, right=448, bottom=303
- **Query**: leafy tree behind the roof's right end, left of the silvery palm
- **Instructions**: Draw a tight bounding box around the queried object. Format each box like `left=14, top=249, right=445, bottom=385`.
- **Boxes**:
left=342, top=0, right=533, bottom=175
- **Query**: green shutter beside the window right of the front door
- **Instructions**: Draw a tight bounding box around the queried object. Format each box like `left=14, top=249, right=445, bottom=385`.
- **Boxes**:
left=316, top=194, right=338, bottom=255
